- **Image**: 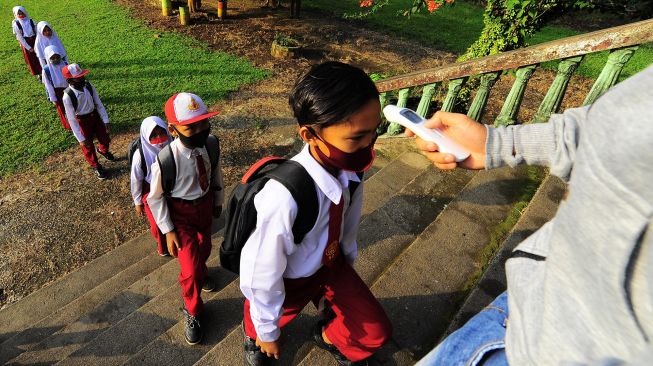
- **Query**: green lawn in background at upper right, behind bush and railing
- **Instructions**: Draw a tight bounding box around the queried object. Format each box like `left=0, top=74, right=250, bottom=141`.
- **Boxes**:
left=305, top=0, right=653, bottom=79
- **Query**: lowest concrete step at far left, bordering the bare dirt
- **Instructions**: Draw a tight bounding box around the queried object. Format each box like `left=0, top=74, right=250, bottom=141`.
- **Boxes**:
left=0, top=233, right=154, bottom=343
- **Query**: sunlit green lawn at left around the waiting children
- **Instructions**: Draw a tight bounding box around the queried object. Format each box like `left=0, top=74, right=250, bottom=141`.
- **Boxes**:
left=0, top=0, right=266, bottom=177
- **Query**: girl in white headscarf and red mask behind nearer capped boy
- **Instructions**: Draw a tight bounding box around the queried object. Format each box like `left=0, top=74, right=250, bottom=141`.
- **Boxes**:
left=130, top=116, right=171, bottom=257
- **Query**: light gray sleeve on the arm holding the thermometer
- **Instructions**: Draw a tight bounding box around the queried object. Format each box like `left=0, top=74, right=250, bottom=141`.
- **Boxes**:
left=485, top=106, right=589, bottom=181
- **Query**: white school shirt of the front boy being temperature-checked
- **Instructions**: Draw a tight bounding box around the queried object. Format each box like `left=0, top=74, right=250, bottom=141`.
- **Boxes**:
left=240, top=145, right=363, bottom=342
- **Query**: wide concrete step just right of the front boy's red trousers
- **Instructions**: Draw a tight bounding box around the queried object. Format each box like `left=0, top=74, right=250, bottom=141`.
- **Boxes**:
left=300, top=167, right=544, bottom=365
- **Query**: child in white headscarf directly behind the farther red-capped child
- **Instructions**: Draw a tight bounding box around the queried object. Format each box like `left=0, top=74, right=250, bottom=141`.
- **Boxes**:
left=41, top=46, right=70, bottom=130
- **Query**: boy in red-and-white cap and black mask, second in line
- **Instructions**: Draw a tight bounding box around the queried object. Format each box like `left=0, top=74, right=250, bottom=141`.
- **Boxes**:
left=147, top=93, right=224, bottom=345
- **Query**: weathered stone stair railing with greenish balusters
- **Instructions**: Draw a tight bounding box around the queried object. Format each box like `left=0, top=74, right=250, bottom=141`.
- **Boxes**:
left=376, top=19, right=653, bottom=134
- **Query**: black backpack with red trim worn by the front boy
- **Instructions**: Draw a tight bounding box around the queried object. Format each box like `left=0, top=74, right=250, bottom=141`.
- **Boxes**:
left=220, top=157, right=362, bottom=274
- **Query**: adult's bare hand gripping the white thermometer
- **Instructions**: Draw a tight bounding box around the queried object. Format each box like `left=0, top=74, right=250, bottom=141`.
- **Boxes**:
left=406, top=111, right=487, bottom=170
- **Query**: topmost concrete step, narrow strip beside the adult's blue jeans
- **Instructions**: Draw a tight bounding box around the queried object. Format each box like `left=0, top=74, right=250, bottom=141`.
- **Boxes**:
left=443, top=175, right=567, bottom=338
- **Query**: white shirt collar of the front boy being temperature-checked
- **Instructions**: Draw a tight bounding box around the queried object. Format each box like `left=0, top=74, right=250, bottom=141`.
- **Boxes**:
left=292, top=144, right=360, bottom=204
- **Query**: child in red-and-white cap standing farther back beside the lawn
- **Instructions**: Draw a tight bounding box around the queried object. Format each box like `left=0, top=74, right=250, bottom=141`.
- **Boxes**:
left=61, top=64, right=115, bottom=180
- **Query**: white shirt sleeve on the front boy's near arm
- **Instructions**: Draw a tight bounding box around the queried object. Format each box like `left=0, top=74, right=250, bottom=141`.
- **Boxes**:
left=240, top=180, right=298, bottom=342
